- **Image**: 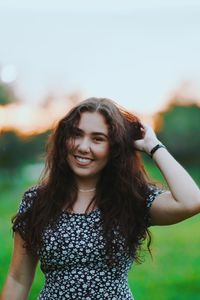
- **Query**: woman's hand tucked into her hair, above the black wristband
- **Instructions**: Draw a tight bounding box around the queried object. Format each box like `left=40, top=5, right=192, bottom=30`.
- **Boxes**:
left=134, top=123, right=161, bottom=155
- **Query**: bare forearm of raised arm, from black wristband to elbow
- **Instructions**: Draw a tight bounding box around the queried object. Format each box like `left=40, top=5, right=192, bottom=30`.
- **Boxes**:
left=153, top=148, right=200, bottom=210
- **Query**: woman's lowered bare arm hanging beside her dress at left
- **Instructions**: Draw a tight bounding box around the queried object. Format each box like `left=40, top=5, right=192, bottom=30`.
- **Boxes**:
left=0, top=232, right=38, bottom=300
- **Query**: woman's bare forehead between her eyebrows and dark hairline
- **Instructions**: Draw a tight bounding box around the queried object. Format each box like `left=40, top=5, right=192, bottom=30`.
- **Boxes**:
left=77, top=112, right=108, bottom=134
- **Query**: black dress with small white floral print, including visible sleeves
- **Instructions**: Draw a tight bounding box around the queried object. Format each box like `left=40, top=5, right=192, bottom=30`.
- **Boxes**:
left=14, top=187, right=162, bottom=300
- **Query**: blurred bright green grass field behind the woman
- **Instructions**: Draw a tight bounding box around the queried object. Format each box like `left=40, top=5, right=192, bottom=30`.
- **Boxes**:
left=0, top=165, right=200, bottom=300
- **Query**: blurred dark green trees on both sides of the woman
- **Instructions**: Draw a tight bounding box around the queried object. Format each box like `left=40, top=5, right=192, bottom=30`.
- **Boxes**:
left=0, top=83, right=200, bottom=174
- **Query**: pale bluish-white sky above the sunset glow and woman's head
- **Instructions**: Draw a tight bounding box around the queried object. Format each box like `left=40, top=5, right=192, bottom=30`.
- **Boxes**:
left=0, top=0, right=200, bottom=113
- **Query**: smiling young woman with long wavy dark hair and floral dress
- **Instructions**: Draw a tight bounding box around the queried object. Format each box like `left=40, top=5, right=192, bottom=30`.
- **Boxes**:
left=1, top=98, right=200, bottom=300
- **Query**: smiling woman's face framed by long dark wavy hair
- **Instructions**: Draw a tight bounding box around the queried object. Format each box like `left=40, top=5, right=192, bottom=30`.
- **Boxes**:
left=67, top=112, right=110, bottom=179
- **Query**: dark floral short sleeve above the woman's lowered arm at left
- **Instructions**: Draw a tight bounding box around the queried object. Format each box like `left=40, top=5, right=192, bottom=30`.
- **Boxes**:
left=13, top=186, right=38, bottom=234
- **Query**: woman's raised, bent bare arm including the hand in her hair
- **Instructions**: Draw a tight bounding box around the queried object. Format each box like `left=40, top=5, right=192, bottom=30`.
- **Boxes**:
left=135, top=125, right=200, bottom=225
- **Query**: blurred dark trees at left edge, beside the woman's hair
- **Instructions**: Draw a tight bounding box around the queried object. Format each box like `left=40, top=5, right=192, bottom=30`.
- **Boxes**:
left=0, top=82, right=50, bottom=175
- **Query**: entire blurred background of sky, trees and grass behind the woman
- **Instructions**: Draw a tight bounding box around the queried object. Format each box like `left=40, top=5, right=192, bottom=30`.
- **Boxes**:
left=0, top=0, right=200, bottom=300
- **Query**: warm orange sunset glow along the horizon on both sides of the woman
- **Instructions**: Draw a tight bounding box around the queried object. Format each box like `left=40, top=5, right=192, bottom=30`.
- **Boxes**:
left=0, top=84, right=200, bottom=136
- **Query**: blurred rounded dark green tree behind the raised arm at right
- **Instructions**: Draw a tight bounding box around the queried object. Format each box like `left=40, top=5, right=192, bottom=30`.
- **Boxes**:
left=155, top=99, right=200, bottom=165
